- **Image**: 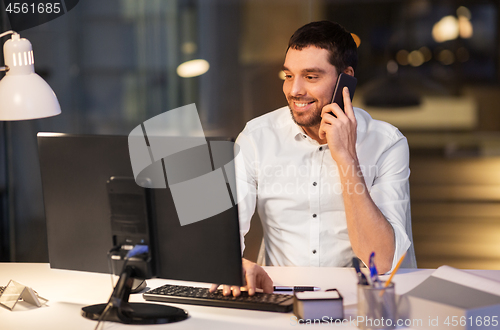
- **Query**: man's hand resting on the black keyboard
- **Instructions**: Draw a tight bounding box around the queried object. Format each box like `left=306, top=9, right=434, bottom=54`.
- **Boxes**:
left=210, top=258, right=273, bottom=297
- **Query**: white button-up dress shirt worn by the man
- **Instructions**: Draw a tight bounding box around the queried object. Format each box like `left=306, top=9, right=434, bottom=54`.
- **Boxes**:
left=235, top=106, right=411, bottom=268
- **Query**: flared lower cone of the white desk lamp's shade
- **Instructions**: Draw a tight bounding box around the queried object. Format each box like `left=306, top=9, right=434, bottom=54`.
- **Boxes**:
left=0, top=73, right=61, bottom=120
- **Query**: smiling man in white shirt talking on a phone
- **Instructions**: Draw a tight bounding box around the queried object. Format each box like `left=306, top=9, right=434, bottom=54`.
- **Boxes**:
left=212, top=21, right=410, bottom=295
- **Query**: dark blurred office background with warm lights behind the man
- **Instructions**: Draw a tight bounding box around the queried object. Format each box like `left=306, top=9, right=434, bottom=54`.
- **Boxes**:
left=0, top=0, right=500, bottom=269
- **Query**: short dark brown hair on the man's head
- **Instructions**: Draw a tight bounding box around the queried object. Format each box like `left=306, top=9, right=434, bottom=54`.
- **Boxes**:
left=287, top=21, right=358, bottom=73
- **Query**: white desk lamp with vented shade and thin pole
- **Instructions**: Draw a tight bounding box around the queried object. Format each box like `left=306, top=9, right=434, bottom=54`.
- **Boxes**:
left=0, top=31, right=61, bottom=261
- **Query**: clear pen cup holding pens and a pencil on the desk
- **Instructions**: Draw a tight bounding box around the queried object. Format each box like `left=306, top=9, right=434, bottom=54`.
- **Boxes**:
left=356, top=283, right=397, bottom=330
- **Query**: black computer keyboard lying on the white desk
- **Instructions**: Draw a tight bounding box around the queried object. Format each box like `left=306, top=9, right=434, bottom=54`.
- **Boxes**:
left=142, top=284, right=293, bottom=313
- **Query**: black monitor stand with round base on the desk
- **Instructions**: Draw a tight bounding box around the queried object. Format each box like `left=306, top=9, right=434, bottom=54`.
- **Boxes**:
left=82, top=266, right=189, bottom=324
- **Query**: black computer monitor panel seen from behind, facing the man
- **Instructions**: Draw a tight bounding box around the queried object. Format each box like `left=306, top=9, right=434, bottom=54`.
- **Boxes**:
left=38, top=133, right=242, bottom=323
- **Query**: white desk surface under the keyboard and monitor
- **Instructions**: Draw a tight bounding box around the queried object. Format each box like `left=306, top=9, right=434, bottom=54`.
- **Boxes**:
left=0, top=263, right=500, bottom=330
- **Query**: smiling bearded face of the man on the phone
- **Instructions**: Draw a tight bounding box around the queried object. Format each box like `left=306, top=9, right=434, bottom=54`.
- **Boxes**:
left=283, top=46, right=338, bottom=127
